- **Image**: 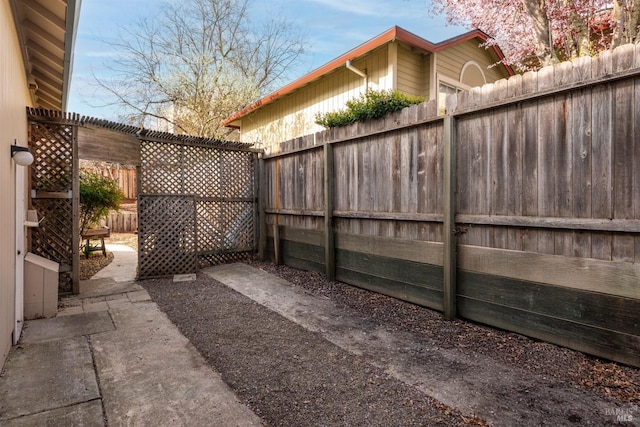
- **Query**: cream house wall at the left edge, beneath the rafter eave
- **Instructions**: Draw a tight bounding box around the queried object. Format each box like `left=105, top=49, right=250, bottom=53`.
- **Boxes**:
left=0, top=1, right=30, bottom=366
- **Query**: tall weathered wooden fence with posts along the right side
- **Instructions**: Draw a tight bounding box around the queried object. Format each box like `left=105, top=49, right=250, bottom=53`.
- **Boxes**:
left=259, top=45, right=640, bottom=366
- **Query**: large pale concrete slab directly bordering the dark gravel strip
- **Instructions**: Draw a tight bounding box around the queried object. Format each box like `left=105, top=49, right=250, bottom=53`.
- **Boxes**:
left=91, top=303, right=261, bottom=426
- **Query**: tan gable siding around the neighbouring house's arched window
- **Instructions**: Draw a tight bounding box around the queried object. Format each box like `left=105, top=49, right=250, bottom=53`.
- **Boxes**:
left=436, top=39, right=508, bottom=83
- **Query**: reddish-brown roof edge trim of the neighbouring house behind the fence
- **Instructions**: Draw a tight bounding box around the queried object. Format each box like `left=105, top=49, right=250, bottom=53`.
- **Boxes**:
left=222, top=26, right=515, bottom=128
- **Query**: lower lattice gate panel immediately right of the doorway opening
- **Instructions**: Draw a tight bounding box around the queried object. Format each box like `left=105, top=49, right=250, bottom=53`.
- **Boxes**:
left=138, top=194, right=196, bottom=277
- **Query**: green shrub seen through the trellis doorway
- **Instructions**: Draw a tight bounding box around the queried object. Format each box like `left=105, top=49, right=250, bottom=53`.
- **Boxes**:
left=80, top=171, right=124, bottom=235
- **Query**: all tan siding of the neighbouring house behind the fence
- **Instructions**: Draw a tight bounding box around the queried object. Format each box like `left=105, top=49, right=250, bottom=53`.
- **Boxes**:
left=240, top=40, right=506, bottom=147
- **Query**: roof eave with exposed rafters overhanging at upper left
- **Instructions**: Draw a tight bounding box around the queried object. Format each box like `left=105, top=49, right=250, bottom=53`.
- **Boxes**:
left=9, top=0, right=82, bottom=111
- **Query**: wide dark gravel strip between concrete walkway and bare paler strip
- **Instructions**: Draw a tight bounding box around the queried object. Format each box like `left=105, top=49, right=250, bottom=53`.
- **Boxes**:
left=141, top=275, right=482, bottom=427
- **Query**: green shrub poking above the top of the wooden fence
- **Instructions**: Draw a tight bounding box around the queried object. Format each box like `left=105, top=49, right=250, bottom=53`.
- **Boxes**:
left=315, top=90, right=424, bottom=128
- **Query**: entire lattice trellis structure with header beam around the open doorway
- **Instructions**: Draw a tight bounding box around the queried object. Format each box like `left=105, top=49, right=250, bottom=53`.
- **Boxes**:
left=27, top=108, right=260, bottom=292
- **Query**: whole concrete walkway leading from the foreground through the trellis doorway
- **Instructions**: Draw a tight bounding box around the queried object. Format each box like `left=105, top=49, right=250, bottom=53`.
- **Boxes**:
left=0, top=246, right=261, bottom=426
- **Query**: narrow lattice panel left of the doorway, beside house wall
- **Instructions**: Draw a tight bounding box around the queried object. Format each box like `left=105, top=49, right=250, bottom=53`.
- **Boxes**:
left=29, top=122, right=73, bottom=293
